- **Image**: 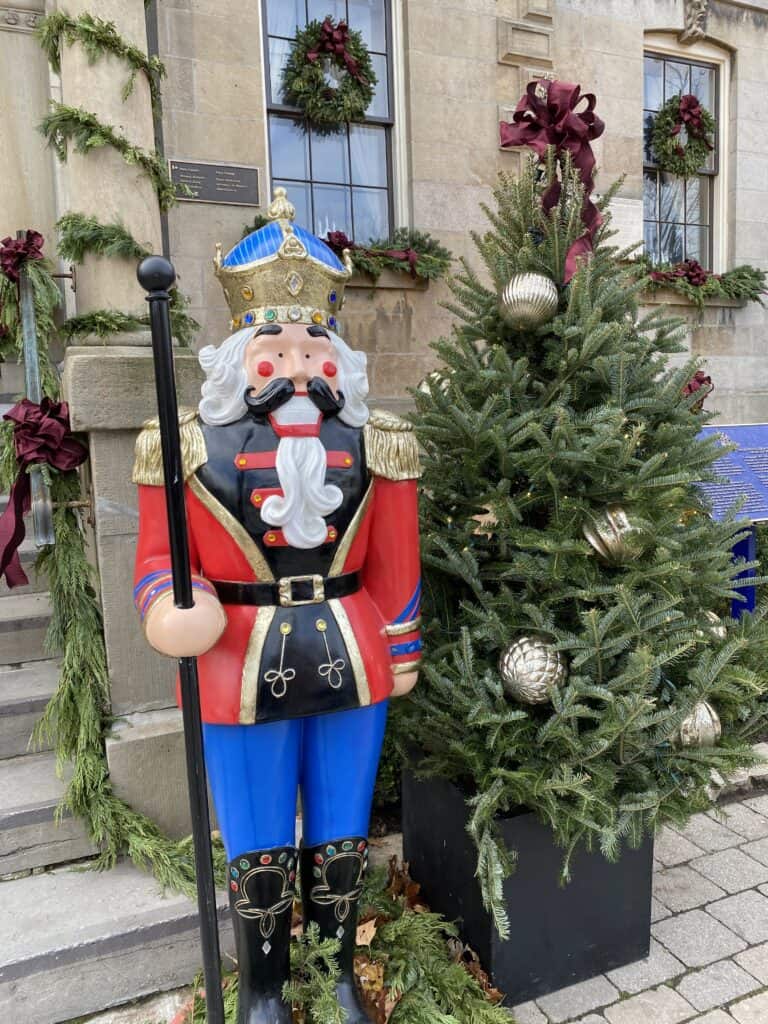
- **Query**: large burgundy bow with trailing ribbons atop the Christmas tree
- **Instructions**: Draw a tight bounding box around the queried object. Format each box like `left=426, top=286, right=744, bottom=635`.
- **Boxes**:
left=499, top=80, right=605, bottom=284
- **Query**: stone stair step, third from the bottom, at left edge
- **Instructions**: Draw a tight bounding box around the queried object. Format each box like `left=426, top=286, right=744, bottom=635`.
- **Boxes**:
left=0, top=660, right=58, bottom=760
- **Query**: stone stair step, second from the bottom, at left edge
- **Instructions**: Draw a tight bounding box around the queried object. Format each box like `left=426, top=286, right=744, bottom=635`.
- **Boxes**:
left=0, top=753, right=96, bottom=872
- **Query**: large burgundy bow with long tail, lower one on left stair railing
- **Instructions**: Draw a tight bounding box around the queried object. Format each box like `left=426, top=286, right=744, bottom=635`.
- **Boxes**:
left=0, top=398, right=88, bottom=587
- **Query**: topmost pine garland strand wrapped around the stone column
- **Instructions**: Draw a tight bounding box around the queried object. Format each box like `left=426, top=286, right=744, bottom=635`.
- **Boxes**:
left=35, top=10, right=166, bottom=111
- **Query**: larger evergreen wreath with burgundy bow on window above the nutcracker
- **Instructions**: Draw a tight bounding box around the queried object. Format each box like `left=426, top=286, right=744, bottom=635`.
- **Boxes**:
left=283, top=16, right=377, bottom=131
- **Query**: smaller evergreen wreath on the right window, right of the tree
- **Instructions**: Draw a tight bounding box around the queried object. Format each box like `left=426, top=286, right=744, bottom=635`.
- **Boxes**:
left=651, top=93, right=715, bottom=178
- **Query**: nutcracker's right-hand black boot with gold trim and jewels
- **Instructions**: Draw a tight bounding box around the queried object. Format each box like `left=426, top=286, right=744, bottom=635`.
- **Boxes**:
left=301, top=836, right=371, bottom=1024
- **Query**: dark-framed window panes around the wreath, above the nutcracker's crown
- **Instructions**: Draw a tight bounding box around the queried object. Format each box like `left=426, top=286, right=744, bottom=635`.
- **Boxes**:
left=264, top=0, right=392, bottom=244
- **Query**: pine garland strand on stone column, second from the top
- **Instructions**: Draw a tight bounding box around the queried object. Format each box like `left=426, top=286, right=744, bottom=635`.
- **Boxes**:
left=40, top=100, right=178, bottom=212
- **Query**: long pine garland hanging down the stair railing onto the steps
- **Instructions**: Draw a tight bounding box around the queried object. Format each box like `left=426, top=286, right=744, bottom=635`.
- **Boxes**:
left=0, top=260, right=226, bottom=897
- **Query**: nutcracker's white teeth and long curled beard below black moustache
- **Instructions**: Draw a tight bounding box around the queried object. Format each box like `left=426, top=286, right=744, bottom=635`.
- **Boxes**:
left=261, top=395, right=343, bottom=548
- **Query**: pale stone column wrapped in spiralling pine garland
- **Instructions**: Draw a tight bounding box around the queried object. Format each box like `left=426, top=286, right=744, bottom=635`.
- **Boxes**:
left=58, top=0, right=161, bottom=313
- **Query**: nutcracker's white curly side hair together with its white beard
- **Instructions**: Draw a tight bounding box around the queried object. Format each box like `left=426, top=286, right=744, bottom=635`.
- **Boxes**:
left=199, top=328, right=369, bottom=548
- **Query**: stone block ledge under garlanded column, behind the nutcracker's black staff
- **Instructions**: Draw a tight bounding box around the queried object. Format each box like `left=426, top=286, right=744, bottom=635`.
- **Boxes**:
left=62, top=345, right=203, bottom=431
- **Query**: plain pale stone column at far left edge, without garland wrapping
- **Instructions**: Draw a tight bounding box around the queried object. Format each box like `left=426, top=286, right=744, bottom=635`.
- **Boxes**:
left=0, top=0, right=56, bottom=240
